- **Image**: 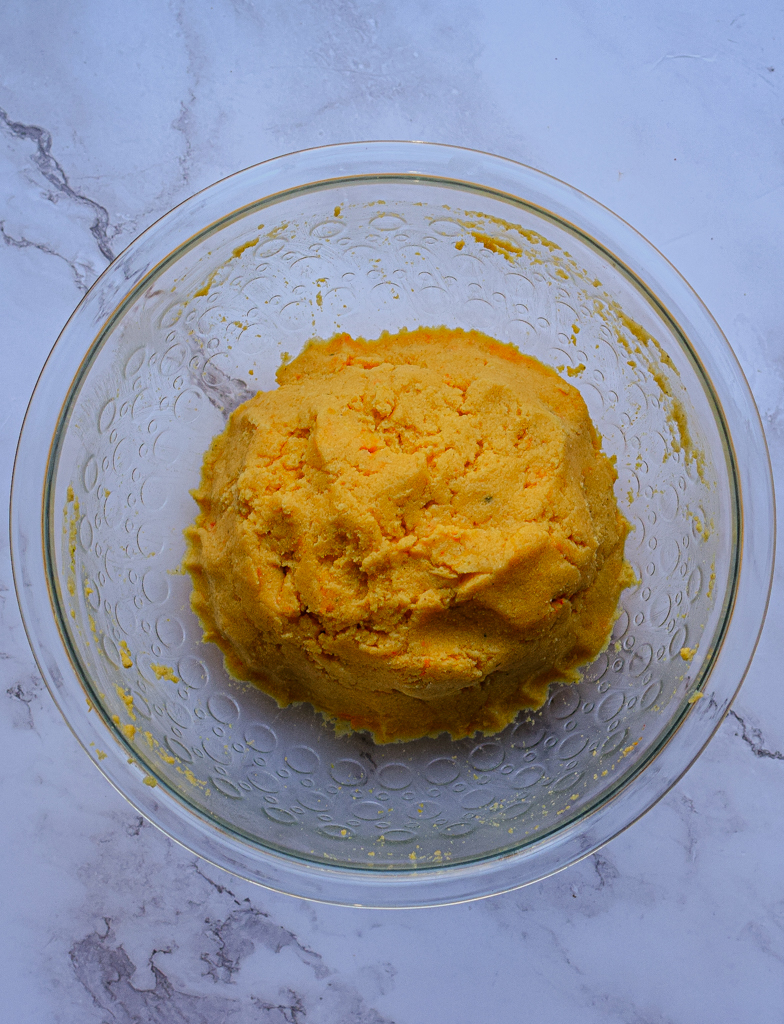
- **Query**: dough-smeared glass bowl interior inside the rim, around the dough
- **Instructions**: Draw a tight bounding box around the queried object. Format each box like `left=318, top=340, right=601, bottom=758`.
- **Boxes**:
left=52, top=176, right=738, bottom=871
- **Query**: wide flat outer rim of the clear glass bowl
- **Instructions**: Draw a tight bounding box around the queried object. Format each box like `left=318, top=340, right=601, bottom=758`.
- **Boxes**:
left=10, top=140, right=776, bottom=907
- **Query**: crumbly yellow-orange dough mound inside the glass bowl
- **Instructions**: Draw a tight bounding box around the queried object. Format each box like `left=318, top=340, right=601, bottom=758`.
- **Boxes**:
left=184, top=328, right=633, bottom=742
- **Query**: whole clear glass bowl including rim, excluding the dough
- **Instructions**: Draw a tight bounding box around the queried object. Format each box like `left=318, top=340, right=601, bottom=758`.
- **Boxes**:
left=11, top=142, right=774, bottom=906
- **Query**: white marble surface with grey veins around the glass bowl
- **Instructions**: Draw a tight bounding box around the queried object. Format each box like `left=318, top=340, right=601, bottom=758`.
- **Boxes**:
left=0, top=0, right=784, bottom=1024
